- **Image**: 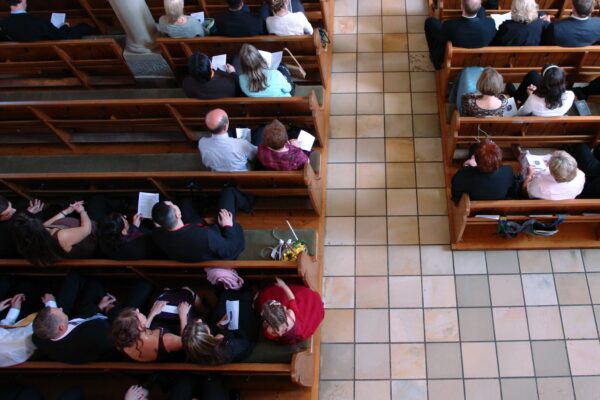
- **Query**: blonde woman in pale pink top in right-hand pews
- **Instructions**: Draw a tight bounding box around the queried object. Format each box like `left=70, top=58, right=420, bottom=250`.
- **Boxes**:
left=523, top=150, right=585, bottom=200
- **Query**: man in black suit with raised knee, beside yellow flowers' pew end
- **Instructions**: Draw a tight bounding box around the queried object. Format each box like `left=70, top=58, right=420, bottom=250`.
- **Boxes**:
left=152, top=187, right=252, bottom=262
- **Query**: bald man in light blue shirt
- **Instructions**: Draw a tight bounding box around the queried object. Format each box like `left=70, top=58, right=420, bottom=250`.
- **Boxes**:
left=198, top=108, right=257, bottom=172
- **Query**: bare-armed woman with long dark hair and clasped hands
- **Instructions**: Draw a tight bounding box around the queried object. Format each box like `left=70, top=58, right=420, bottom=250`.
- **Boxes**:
left=13, top=201, right=97, bottom=266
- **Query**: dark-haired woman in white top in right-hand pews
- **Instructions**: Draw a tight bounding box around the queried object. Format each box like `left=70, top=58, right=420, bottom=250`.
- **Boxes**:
left=515, top=64, right=575, bottom=117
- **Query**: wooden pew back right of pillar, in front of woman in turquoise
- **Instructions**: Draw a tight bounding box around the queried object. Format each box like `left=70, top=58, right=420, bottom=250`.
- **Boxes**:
left=156, top=30, right=331, bottom=88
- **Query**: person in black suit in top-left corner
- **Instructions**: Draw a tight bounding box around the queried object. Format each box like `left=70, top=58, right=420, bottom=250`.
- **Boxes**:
left=0, top=0, right=92, bottom=42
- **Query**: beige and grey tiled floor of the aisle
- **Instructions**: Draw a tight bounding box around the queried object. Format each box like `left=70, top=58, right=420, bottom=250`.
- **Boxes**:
left=320, top=0, right=600, bottom=400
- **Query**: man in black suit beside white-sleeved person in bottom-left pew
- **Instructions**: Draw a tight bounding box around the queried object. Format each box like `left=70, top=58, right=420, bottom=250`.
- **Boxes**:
left=33, top=273, right=152, bottom=364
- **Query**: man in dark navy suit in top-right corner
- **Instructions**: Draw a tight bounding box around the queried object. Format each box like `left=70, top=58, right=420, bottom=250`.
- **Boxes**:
left=542, top=0, right=600, bottom=47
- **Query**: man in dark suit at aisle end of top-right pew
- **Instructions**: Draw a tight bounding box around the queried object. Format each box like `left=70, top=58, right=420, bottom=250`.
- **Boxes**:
left=425, top=0, right=496, bottom=69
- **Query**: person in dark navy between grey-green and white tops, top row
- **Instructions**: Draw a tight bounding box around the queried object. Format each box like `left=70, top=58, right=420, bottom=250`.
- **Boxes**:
left=215, top=0, right=266, bottom=37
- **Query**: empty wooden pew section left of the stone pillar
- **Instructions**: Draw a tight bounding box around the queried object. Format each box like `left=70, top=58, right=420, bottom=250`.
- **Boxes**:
left=0, top=39, right=135, bottom=89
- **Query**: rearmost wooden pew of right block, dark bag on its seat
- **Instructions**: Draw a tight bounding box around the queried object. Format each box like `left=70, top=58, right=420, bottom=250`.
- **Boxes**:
left=449, top=194, right=600, bottom=250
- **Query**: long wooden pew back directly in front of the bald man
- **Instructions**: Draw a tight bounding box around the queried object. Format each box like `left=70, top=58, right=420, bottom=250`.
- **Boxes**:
left=0, top=91, right=327, bottom=154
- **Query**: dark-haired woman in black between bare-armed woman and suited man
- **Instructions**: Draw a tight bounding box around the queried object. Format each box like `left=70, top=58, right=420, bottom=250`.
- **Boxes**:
left=98, top=212, right=165, bottom=260
